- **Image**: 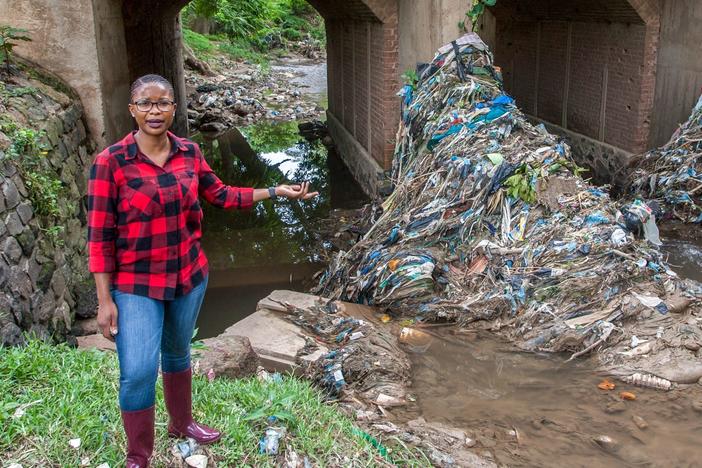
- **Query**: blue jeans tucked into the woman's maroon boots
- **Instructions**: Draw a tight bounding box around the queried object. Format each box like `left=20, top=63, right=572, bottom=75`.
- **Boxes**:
left=111, top=278, right=207, bottom=411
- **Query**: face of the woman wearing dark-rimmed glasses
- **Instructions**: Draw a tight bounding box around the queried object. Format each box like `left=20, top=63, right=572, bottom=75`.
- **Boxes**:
left=129, top=83, right=176, bottom=136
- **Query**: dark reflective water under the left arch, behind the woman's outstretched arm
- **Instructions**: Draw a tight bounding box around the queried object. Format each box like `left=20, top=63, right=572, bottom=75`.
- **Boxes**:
left=196, top=122, right=366, bottom=338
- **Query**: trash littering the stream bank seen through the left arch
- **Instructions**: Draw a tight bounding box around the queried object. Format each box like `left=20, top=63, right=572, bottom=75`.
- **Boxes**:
left=185, top=58, right=324, bottom=132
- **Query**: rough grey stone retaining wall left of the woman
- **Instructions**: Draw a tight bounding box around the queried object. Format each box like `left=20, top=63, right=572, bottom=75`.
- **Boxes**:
left=0, top=66, right=95, bottom=345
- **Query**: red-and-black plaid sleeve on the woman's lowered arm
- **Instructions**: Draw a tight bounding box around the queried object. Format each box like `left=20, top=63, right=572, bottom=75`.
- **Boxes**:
left=88, top=154, right=117, bottom=273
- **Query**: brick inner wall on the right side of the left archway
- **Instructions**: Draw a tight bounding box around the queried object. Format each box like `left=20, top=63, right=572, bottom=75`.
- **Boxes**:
left=310, top=0, right=400, bottom=169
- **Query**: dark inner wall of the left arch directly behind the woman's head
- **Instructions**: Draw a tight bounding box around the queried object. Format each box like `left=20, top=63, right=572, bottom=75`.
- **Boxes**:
left=122, top=0, right=188, bottom=136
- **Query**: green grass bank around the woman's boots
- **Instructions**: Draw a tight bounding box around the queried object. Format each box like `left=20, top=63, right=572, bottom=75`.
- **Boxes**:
left=0, top=341, right=427, bottom=467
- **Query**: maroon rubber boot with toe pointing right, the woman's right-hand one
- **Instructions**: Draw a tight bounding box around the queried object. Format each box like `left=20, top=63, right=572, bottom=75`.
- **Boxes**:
left=163, top=369, right=222, bottom=445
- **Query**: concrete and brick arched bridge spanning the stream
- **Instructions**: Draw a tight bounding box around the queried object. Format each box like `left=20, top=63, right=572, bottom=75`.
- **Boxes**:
left=0, top=0, right=702, bottom=193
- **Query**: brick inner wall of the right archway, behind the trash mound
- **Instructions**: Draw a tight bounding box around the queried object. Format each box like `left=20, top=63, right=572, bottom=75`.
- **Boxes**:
left=493, top=0, right=659, bottom=153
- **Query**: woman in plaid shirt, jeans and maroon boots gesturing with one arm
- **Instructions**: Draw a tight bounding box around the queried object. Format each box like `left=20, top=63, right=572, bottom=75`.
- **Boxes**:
left=88, top=75, right=317, bottom=467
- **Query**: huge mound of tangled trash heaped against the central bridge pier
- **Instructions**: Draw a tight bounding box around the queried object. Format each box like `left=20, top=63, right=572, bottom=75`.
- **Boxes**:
left=315, top=33, right=702, bottom=370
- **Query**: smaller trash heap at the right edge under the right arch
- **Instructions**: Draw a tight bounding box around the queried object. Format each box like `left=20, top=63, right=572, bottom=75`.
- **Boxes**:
left=629, top=96, right=702, bottom=223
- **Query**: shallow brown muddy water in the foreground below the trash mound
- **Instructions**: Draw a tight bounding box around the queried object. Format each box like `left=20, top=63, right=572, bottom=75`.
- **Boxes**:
left=408, top=332, right=702, bottom=467
